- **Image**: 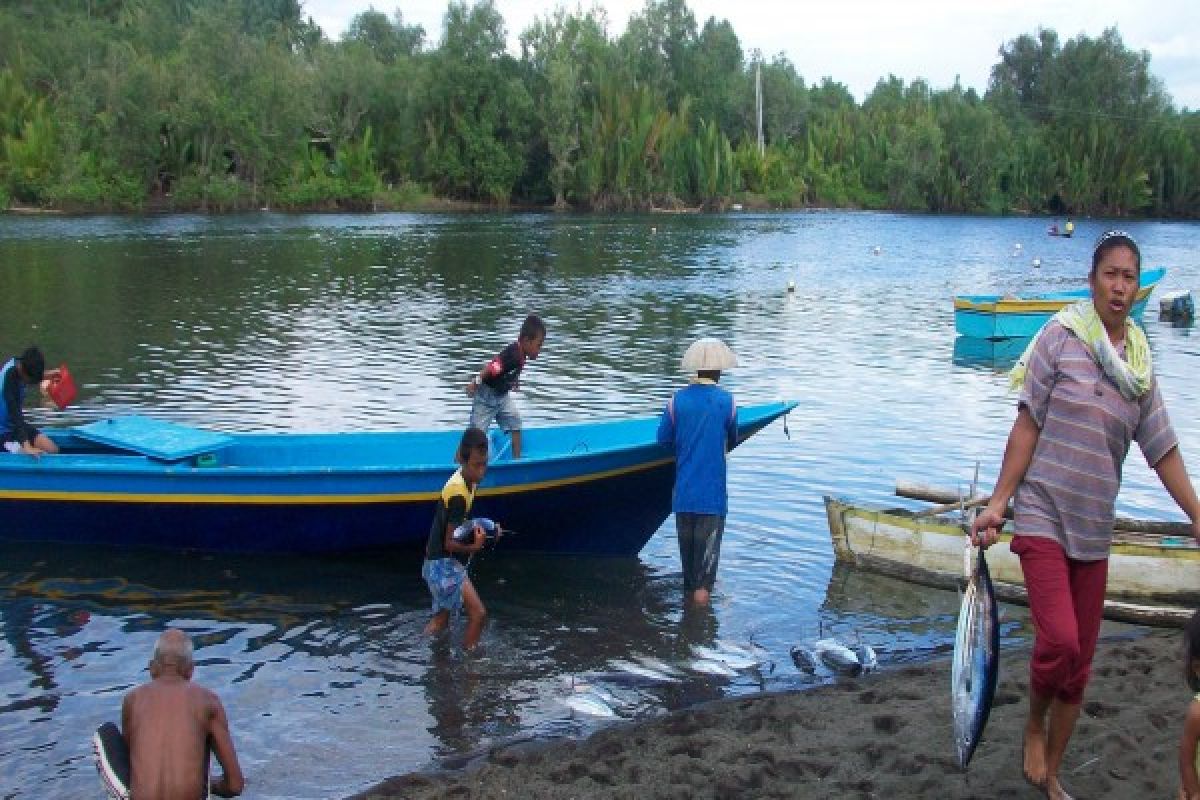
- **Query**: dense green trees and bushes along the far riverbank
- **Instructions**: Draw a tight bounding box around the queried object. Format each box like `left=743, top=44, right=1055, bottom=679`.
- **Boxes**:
left=0, top=0, right=1200, bottom=217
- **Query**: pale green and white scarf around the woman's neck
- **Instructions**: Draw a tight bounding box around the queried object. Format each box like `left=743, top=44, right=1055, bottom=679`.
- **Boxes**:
left=1008, top=300, right=1154, bottom=401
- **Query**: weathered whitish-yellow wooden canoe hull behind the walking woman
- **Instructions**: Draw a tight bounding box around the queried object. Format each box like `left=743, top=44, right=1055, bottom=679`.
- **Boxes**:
left=824, top=495, right=1200, bottom=626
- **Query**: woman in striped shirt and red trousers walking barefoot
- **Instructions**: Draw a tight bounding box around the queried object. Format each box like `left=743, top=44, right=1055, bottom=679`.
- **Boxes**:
left=971, top=230, right=1200, bottom=798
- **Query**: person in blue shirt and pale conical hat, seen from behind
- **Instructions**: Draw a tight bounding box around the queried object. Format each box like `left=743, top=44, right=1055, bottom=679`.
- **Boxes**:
left=658, top=338, right=738, bottom=606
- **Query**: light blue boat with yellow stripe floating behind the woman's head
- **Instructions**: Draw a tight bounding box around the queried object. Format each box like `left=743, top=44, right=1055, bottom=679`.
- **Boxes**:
left=954, top=266, right=1166, bottom=339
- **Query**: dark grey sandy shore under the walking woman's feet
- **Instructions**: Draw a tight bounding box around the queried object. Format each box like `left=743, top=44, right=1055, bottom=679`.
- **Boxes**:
left=355, top=628, right=1190, bottom=800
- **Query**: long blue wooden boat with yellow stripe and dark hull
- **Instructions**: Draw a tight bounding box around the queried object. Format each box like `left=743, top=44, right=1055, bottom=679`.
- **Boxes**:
left=0, top=403, right=796, bottom=555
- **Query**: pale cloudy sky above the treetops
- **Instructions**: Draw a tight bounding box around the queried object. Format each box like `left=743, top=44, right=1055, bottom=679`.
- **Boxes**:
left=302, top=0, right=1200, bottom=110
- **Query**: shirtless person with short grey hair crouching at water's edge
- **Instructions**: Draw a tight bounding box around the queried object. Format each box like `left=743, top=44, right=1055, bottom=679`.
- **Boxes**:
left=121, top=628, right=246, bottom=800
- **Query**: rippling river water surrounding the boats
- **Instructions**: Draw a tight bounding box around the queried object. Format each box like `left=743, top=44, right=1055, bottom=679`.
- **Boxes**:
left=0, top=211, right=1200, bottom=798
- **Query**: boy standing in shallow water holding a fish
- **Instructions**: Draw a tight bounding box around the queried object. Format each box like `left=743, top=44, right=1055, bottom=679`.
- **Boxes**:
left=421, top=427, right=487, bottom=650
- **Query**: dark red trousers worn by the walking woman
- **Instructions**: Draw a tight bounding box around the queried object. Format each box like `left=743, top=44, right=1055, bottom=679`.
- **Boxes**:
left=1012, top=536, right=1109, bottom=705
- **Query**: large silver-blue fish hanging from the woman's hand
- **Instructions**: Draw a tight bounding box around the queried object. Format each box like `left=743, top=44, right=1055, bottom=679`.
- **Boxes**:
left=950, top=548, right=1000, bottom=770
